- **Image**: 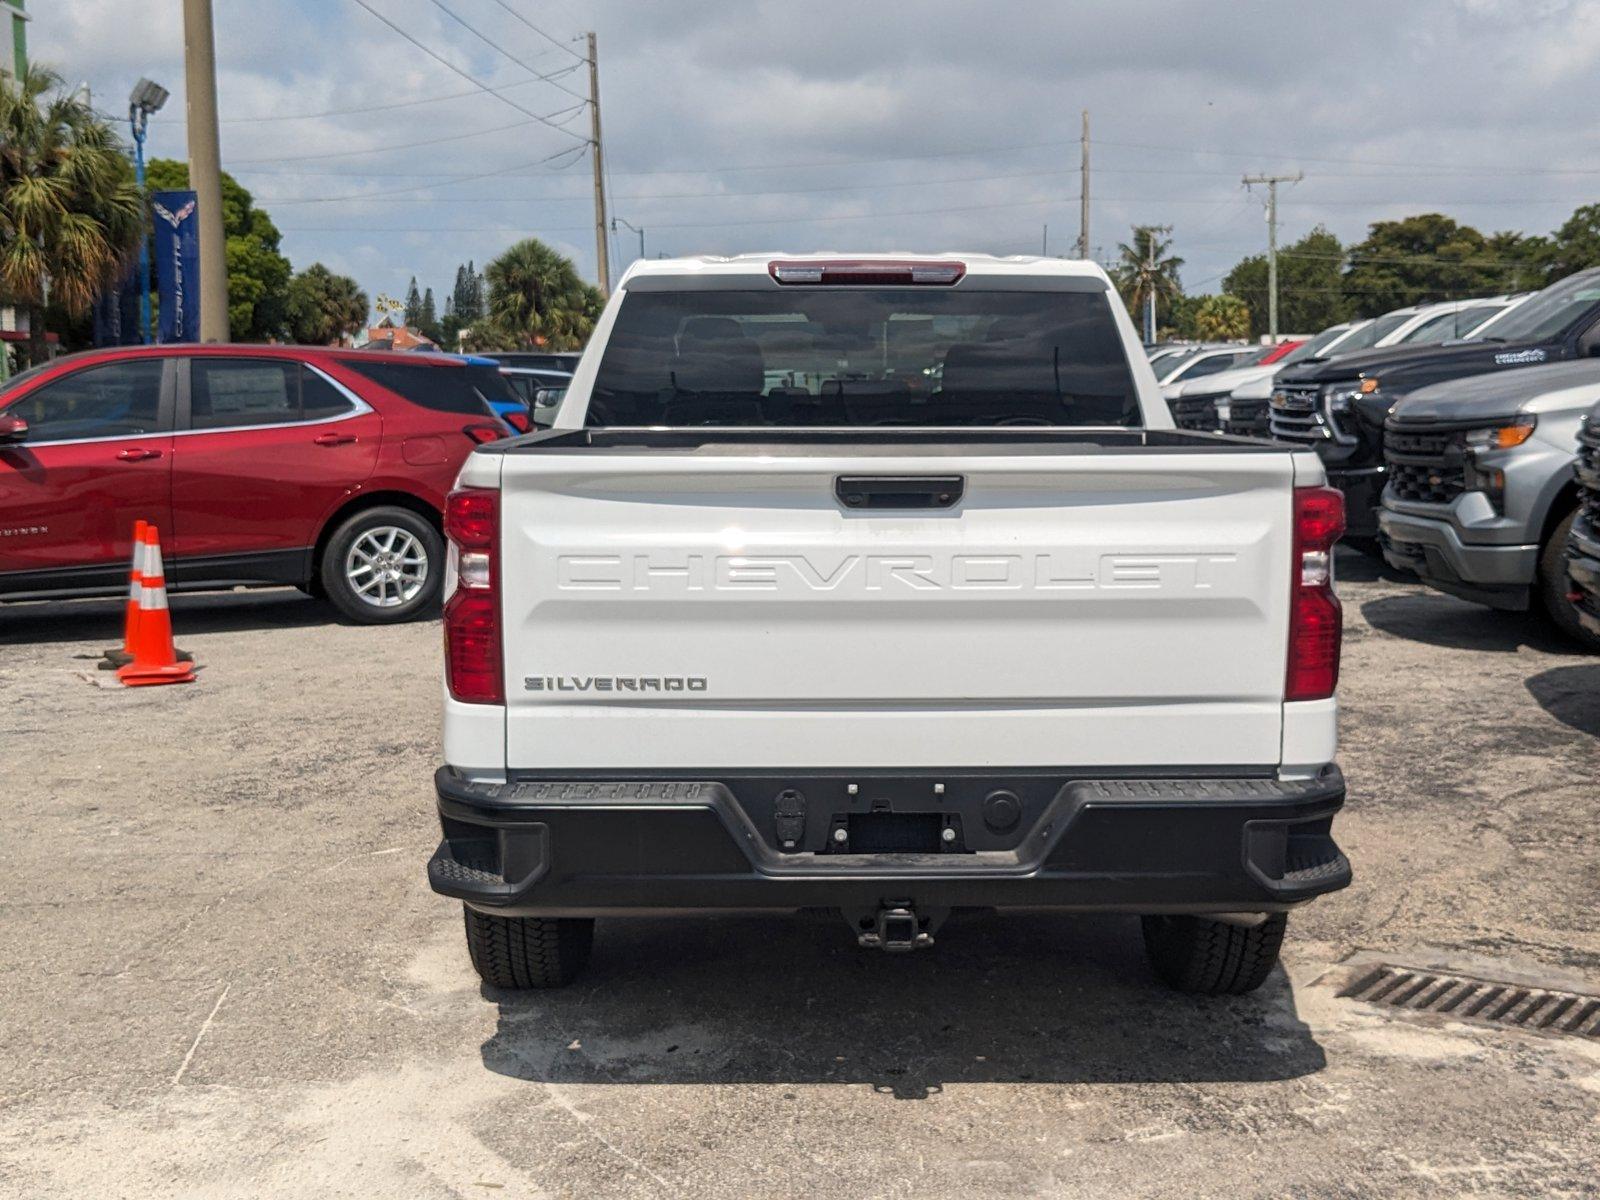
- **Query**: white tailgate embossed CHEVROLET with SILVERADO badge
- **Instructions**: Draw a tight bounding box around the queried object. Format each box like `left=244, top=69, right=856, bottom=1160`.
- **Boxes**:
left=501, top=445, right=1294, bottom=773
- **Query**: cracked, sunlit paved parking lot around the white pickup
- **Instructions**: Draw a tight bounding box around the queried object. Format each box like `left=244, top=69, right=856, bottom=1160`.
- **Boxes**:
left=0, top=555, right=1600, bottom=1197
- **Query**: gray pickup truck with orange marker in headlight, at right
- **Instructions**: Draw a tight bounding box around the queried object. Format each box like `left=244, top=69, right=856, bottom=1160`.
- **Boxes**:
left=1378, top=360, right=1600, bottom=651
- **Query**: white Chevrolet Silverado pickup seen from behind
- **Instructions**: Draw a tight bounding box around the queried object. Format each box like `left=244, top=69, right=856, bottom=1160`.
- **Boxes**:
left=429, top=254, right=1350, bottom=994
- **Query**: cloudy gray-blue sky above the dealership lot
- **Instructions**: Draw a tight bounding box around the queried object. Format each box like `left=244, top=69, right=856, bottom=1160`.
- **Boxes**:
left=29, top=0, right=1600, bottom=316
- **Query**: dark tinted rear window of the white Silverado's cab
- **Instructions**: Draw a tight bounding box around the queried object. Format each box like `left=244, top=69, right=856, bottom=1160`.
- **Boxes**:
left=587, top=288, right=1139, bottom=427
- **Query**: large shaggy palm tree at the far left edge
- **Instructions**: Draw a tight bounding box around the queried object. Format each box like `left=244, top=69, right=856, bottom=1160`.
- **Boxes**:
left=0, top=67, right=146, bottom=362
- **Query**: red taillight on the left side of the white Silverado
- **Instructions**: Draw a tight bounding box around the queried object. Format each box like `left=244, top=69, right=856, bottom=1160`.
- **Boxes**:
left=445, top=488, right=506, bottom=704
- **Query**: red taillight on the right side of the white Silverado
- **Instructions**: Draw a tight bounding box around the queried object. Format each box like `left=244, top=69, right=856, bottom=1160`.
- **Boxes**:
left=1283, top=488, right=1344, bottom=701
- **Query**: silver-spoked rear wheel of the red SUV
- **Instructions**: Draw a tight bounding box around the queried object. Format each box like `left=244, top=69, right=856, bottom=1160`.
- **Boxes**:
left=318, top=506, right=445, bottom=626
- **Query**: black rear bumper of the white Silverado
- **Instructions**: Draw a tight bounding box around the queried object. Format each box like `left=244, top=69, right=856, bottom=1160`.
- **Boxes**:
left=427, top=766, right=1350, bottom=915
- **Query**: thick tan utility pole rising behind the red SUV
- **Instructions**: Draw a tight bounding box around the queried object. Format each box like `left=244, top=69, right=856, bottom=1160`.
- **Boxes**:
left=184, top=0, right=227, bottom=342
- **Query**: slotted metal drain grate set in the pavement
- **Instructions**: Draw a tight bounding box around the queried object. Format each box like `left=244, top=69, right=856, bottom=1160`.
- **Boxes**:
left=1339, top=963, right=1600, bottom=1038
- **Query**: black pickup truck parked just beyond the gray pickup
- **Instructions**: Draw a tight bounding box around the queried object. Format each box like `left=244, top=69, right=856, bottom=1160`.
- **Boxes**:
left=1270, top=267, right=1600, bottom=544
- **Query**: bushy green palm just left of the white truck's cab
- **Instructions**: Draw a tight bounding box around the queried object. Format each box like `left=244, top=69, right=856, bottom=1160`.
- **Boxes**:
left=472, top=237, right=602, bottom=350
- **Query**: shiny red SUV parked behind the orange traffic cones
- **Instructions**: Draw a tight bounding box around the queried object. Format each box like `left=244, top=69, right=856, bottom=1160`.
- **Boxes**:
left=0, top=346, right=515, bottom=624
